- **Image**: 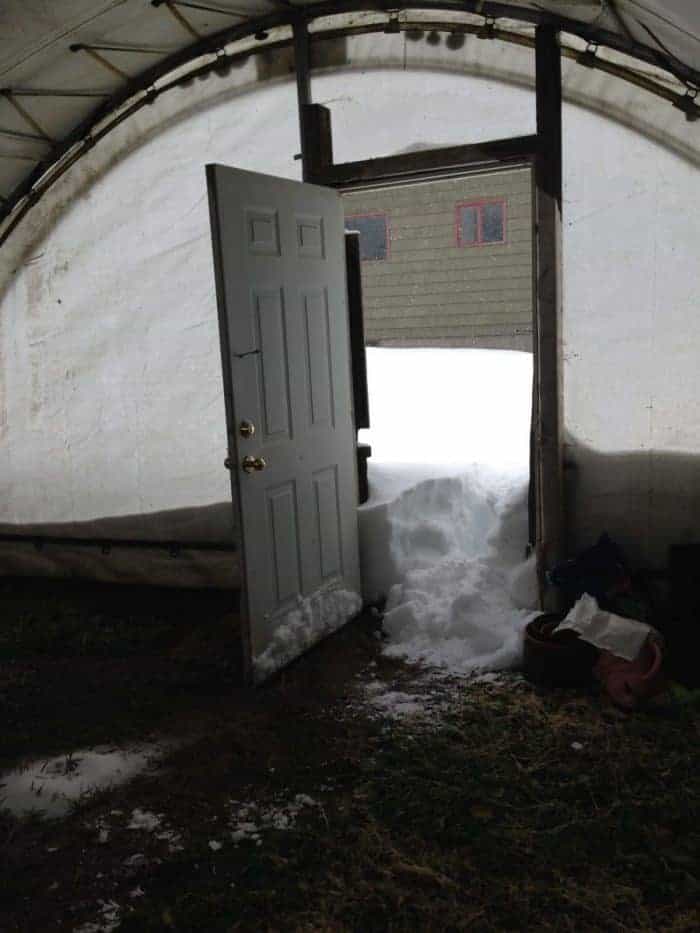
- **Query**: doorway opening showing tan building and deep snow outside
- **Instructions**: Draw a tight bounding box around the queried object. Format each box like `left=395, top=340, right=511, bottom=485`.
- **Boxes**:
left=343, top=167, right=537, bottom=673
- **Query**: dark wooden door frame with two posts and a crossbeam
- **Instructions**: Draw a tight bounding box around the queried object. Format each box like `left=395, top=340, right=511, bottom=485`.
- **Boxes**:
left=295, top=26, right=566, bottom=608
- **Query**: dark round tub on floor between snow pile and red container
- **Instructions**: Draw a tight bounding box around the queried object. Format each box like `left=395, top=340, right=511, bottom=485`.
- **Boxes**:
left=524, top=613, right=598, bottom=687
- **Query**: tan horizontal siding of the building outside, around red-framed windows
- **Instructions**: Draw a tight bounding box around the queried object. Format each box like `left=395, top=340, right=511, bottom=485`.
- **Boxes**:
left=343, top=169, right=532, bottom=349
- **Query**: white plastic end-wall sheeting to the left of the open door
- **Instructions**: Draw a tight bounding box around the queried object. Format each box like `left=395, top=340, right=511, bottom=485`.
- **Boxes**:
left=0, top=70, right=299, bottom=586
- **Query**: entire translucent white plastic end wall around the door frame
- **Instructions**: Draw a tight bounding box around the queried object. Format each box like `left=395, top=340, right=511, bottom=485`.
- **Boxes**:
left=0, top=52, right=700, bottom=584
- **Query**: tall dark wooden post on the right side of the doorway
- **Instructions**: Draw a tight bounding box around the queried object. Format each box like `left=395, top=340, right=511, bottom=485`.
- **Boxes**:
left=534, top=26, right=565, bottom=608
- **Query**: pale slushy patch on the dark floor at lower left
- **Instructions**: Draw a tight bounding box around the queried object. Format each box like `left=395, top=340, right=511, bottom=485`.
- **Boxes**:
left=0, top=745, right=163, bottom=818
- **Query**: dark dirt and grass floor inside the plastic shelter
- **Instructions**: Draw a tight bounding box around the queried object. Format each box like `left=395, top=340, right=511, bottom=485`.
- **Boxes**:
left=0, top=580, right=700, bottom=933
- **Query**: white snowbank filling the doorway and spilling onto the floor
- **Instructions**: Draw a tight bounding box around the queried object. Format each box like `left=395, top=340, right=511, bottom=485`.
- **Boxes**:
left=360, top=348, right=537, bottom=673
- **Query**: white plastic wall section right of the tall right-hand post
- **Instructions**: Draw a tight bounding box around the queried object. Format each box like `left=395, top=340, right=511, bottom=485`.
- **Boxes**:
left=564, top=109, right=700, bottom=566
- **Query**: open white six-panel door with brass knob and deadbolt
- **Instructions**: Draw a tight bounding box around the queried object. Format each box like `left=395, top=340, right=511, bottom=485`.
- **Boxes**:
left=207, top=165, right=362, bottom=682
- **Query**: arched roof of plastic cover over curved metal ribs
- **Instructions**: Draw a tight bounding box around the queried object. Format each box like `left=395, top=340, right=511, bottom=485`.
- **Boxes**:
left=0, top=0, right=700, bottom=248
